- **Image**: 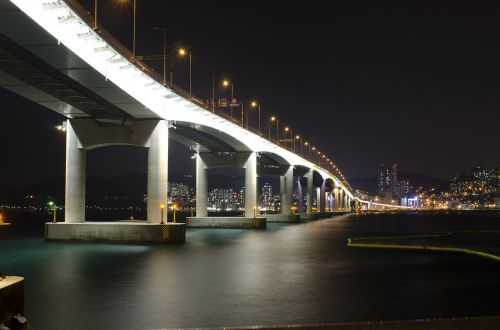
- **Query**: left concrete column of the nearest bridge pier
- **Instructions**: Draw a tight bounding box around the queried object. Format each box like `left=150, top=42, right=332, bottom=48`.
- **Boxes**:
left=64, top=120, right=86, bottom=223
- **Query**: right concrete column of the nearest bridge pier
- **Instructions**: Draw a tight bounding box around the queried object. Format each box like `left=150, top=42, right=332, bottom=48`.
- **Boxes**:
left=147, top=120, right=168, bottom=223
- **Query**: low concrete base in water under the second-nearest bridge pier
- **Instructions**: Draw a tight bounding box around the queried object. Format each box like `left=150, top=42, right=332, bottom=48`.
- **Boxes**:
left=186, top=217, right=267, bottom=229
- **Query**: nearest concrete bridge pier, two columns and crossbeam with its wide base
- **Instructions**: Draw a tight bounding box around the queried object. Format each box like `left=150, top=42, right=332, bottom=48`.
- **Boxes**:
left=45, top=119, right=185, bottom=243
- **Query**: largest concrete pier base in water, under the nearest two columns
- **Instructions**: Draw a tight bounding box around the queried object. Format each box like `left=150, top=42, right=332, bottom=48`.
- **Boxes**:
left=45, top=221, right=186, bottom=243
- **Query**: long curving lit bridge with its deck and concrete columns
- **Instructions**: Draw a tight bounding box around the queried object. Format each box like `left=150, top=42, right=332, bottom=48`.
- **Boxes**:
left=0, top=0, right=398, bottom=242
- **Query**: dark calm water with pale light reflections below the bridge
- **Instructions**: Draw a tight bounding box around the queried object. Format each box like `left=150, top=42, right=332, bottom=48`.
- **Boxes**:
left=0, top=213, right=500, bottom=330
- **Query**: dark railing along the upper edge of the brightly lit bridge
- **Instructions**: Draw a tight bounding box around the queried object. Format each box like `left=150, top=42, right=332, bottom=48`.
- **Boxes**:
left=63, top=0, right=348, bottom=182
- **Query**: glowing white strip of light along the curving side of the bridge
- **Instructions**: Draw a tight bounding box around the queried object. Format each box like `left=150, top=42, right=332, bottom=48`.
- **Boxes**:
left=10, top=0, right=354, bottom=198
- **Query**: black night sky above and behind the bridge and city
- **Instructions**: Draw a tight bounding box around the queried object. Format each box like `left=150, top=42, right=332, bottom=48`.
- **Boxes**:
left=0, top=0, right=500, bottom=186
